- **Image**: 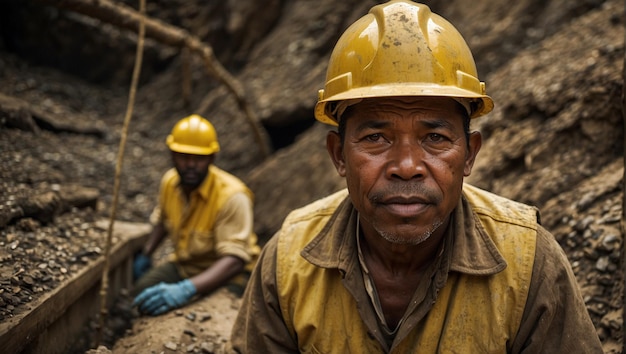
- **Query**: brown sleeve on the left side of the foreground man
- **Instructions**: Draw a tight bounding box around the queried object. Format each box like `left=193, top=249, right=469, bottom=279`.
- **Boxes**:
left=231, top=236, right=300, bottom=354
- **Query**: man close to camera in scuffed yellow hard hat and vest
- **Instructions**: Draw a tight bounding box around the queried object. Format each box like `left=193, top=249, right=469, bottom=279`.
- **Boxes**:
left=232, top=0, right=602, bottom=354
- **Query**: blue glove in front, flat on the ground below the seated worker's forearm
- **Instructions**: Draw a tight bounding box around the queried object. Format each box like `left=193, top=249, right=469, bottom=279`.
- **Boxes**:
left=133, top=279, right=196, bottom=316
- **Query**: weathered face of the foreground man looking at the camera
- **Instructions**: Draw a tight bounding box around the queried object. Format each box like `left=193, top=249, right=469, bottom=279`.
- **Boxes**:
left=327, top=97, right=481, bottom=245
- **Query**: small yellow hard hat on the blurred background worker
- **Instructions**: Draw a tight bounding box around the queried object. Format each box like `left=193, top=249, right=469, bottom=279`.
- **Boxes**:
left=165, top=114, right=220, bottom=155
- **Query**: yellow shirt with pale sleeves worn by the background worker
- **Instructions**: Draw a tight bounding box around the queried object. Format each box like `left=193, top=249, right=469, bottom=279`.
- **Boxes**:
left=151, top=165, right=260, bottom=277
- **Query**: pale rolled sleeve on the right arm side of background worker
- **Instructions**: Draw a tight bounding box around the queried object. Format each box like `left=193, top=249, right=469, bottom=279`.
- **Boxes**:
left=214, top=193, right=254, bottom=263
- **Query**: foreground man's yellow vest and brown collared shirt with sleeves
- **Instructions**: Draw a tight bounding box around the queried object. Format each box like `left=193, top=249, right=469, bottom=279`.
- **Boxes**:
left=232, top=185, right=602, bottom=354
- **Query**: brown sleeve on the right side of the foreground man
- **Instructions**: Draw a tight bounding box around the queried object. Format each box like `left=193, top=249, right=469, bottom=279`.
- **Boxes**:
left=512, top=226, right=603, bottom=353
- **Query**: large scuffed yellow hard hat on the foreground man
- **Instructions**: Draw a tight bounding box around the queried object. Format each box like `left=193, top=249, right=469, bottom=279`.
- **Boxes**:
left=315, top=0, right=493, bottom=125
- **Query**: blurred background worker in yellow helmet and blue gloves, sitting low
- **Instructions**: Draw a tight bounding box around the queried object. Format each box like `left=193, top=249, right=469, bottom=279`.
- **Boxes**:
left=131, top=115, right=260, bottom=315
